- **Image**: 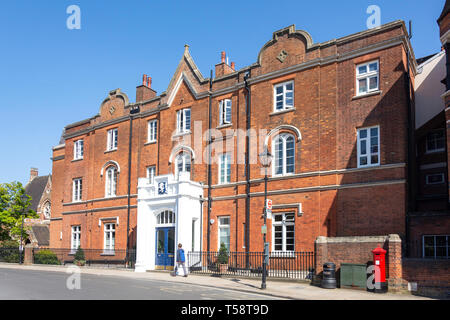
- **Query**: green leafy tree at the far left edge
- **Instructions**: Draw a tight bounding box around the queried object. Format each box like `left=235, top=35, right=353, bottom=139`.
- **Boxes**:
left=0, top=182, right=39, bottom=241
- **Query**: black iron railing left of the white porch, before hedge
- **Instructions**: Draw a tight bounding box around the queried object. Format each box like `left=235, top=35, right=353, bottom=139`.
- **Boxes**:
left=33, top=248, right=136, bottom=268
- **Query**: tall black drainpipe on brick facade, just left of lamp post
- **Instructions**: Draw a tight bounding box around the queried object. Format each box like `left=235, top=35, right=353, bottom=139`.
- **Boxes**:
left=244, top=70, right=251, bottom=268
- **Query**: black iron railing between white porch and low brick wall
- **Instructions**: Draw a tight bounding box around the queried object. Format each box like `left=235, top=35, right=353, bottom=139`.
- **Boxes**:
left=187, top=252, right=315, bottom=280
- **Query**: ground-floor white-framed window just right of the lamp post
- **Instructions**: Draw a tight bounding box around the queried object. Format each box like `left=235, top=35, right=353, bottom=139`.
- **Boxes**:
left=272, top=212, right=295, bottom=252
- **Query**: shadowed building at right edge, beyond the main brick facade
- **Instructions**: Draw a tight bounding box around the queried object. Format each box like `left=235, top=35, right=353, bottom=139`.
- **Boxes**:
left=408, top=1, right=450, bottom=259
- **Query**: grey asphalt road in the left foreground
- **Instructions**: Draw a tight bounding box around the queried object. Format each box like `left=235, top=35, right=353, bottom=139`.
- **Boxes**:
left=0, top=268, right=282, bottom=300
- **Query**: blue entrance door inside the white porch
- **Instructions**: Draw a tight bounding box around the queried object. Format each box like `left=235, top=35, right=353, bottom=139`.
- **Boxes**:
left=156, top=227, right=175, bottom=270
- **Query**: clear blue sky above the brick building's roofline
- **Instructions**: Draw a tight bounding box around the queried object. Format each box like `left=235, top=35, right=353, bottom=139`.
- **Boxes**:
left=0, top=0, right=445, bottom=183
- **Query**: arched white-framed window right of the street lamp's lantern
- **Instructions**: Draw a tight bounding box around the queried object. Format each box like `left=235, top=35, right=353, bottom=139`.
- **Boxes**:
left=272, top=133, right=295, bottom=176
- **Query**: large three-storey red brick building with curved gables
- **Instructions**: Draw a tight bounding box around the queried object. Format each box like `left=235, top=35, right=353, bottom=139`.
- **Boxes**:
left=50, top=21, right=416, bottom=270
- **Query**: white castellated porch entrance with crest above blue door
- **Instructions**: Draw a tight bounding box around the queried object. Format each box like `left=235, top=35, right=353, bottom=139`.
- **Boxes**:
left=135, top=172, right=203, bottom=272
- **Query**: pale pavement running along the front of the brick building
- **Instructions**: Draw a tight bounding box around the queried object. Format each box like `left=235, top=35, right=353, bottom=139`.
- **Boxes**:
left=0, top=263, right=433, bottom=300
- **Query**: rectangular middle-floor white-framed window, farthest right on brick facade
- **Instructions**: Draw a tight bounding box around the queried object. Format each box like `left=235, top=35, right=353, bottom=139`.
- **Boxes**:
left=357, top=126, right=380, bottom=168
